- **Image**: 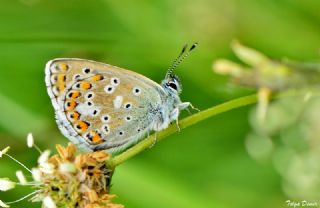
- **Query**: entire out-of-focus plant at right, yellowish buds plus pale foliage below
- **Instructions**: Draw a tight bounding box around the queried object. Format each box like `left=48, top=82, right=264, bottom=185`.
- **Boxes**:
left=213, top=42, right=320, bottom=203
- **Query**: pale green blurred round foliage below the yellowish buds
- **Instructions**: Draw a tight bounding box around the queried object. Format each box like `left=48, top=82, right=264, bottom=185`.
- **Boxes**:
left=246, top=93, right=320, bottom=200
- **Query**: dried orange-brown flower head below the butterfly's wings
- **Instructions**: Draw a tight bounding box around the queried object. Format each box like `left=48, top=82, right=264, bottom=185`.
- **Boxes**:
left=32, top=143, right=123, bottom=208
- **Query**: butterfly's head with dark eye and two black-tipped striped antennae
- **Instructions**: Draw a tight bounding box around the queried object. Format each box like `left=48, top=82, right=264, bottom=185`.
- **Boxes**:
left=162, top=43, right=198, bottom=94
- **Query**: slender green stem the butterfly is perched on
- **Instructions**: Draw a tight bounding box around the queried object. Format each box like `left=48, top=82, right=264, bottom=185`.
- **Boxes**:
left=109, top=95, right=257, bottom=168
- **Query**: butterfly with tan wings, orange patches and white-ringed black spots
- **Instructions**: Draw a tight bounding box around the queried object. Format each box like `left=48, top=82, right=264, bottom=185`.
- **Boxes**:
left=45, top=43, right=197, bottom=154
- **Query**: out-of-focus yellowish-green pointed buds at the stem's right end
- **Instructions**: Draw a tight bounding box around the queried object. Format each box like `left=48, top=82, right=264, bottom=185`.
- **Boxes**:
left=213, top=41, right=320, bottom=92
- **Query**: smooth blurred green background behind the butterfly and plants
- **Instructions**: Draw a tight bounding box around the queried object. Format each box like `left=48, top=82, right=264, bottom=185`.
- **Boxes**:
left=0, top=0, right=320, bottom=208
